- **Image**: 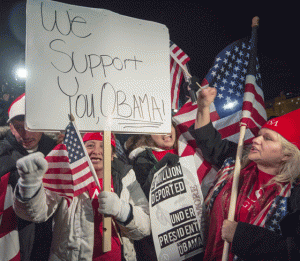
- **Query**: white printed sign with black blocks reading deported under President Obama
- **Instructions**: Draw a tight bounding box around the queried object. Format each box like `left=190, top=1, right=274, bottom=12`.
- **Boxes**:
left=149, top=156, right=204, bottom=261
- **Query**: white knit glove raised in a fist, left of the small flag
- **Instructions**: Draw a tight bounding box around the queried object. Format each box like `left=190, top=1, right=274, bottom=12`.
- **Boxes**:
left=17, top=152, right=48, bottom=199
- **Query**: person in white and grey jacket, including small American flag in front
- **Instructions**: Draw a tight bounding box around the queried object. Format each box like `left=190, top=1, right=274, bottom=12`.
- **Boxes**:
left=14, top=122, right=150, bottom=261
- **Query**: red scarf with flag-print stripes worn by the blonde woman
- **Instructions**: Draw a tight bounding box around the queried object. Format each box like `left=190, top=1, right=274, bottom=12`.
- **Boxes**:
left=204, top=162, right=291, bottom=260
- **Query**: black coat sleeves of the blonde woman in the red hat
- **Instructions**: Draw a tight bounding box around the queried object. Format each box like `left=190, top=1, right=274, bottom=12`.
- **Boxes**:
left=189, top=122, right=300, bottom=261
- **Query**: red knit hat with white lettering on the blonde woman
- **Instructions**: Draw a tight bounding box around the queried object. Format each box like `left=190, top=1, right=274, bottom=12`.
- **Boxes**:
left=261, top=109, right=300, bottom=149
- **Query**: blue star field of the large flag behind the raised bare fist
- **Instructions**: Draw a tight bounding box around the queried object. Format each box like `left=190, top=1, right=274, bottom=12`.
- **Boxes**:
left=205, top=39, right=261, bottom=118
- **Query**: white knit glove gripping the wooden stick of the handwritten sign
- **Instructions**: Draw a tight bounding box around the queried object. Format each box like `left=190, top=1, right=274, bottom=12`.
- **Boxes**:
left=98, top=191, right=130, bottom=223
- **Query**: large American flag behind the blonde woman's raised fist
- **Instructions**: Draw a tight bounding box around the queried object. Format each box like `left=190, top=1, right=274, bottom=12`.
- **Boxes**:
left=173, top=28, right=267, bottom=194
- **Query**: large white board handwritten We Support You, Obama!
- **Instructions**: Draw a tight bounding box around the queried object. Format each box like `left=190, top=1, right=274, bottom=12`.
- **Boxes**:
left=26, top=0, right=171, bottom=133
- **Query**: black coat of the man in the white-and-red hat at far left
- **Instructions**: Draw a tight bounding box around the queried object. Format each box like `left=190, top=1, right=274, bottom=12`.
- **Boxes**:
left=0, top=131, right=56, bottom=261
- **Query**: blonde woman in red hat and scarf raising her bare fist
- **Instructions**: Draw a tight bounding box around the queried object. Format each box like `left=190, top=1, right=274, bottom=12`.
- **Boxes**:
left=190, top=87, right=300, bottom=261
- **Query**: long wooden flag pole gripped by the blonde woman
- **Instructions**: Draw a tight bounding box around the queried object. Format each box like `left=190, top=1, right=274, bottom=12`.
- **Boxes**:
left=222, top=16, right=259, bottom=261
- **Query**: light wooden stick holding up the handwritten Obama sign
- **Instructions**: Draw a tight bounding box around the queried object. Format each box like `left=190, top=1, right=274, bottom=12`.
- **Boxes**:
left=102, top=131, right=112, bottom=252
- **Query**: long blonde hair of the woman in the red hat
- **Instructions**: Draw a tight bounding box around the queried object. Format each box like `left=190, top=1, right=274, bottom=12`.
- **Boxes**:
left=241, top=133, right=300, bottom=186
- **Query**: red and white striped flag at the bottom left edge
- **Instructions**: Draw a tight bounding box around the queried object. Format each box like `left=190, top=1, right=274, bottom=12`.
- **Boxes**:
left=0, top=173, right=21, bottom=261
